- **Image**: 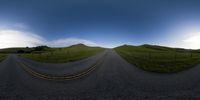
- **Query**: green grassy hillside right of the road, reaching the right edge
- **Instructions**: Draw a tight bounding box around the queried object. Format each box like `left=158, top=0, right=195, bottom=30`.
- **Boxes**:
left=115, top=45, right=200, bottom=73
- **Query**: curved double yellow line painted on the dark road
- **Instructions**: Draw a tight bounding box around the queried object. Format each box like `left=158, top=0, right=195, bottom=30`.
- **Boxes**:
left=18, top=55, right=103, bottom=80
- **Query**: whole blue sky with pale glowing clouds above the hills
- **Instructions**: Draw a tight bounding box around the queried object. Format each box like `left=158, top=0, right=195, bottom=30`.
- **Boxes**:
left=0, top=0, right=200, bottom=49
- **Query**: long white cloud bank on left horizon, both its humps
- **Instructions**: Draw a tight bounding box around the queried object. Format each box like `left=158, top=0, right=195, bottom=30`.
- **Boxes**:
left=0, top=29, right=98, bottom=48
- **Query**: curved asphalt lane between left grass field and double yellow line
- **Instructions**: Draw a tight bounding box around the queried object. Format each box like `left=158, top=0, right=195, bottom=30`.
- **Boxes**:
left=17, top=51, right=106, bottom=76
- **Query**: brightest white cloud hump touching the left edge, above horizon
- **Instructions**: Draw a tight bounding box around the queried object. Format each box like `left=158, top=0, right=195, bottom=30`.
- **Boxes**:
left=0, top=30, right=45, bottom=48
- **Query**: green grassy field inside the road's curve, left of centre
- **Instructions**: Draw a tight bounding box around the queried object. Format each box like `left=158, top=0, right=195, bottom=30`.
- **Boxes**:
left=21, top=44, right=104, bottom=63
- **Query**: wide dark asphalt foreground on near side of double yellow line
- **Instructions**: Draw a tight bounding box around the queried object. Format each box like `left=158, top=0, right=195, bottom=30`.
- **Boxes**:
left=0, top=50, right=200, bottom=100
